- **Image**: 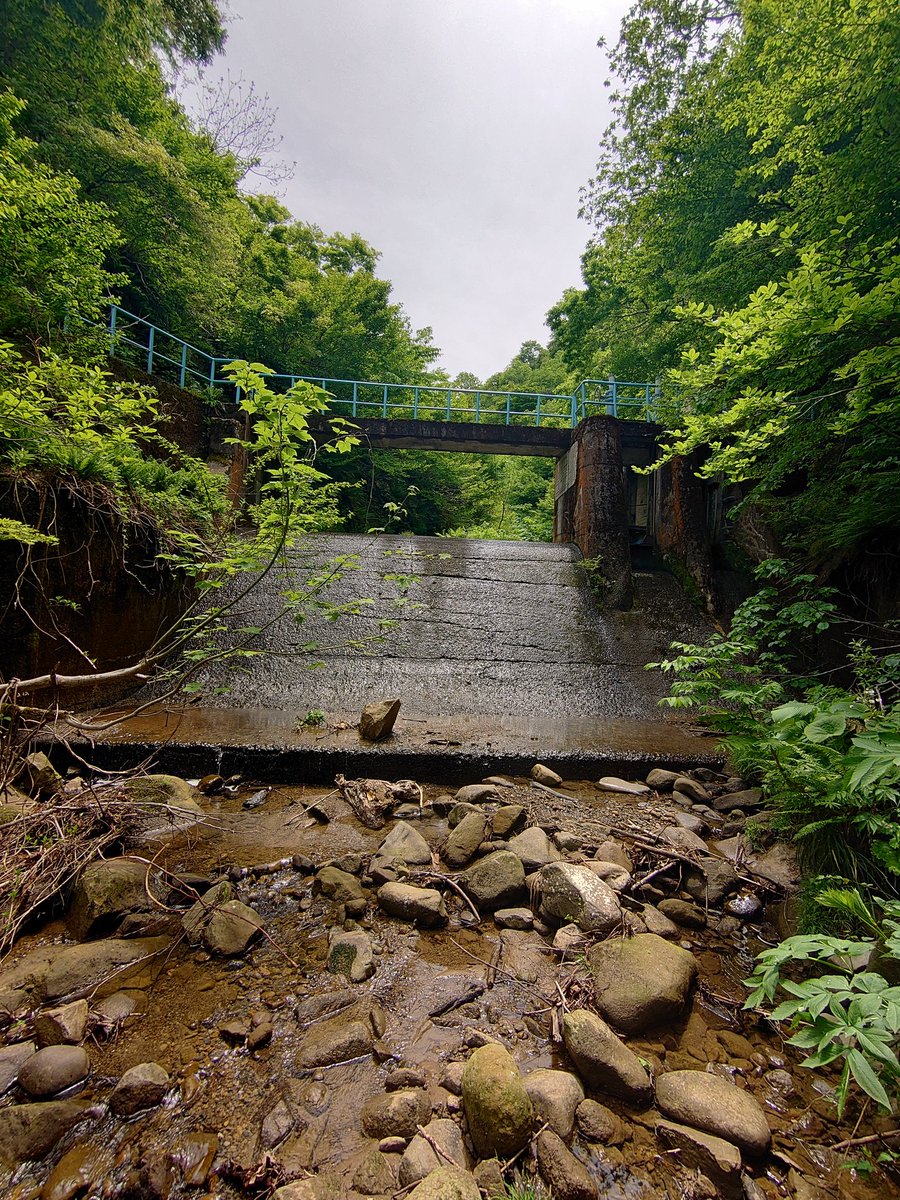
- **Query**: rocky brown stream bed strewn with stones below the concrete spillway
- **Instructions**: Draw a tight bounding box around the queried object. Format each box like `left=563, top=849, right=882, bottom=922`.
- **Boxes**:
left=0, top=767, right=899, bottom=1200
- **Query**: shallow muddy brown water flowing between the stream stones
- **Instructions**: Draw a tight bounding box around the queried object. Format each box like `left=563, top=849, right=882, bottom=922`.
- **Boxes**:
left=0, top=784, right=898, bottom=1200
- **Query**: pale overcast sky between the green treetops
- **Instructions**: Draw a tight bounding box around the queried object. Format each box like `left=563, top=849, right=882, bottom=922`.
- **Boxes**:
left=190, top=0, right=628, bottom=378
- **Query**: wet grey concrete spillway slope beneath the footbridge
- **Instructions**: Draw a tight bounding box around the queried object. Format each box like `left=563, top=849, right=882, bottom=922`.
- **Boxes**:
left=81, top=535, right=715, bottom=781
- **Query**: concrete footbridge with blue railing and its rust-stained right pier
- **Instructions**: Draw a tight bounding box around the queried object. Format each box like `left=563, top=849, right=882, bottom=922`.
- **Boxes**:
left=100, top=305, right=719, bottom=607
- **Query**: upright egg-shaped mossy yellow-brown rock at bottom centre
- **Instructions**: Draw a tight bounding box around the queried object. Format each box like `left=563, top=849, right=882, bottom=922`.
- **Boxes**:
left=462, top=1043, right=534, bottom=1158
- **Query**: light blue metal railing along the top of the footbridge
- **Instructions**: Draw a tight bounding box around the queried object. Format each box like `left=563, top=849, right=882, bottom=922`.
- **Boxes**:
left=95, top=305, right=660, bottom=428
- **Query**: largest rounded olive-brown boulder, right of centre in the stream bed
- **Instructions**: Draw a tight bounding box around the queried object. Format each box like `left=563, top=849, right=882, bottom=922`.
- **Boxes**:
left=588, top=934, right=697, bottom=1033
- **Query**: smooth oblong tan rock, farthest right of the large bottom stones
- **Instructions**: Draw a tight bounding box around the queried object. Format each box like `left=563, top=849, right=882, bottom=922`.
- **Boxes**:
left=656, top=1070, right=772, bottom=1154
